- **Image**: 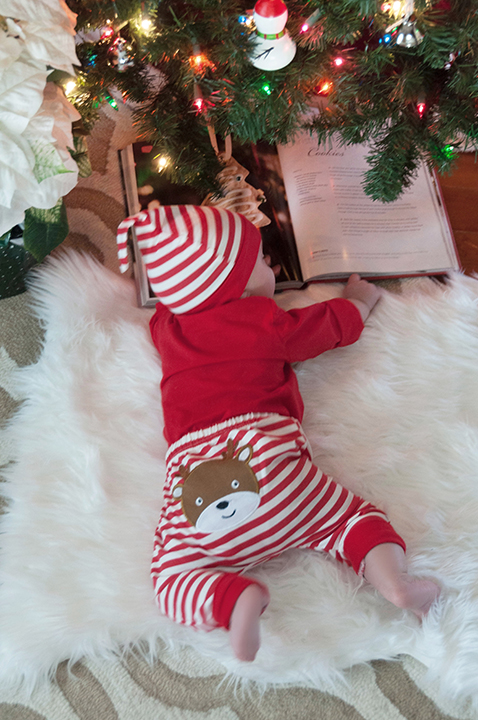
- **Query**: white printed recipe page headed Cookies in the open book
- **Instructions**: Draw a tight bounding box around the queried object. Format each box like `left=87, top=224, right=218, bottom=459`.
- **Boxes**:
left=278, top=133, right=459, bottom=279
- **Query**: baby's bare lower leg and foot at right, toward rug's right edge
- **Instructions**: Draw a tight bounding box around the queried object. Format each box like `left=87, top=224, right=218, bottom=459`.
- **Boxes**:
left=363, top=543, right=440, bottom=618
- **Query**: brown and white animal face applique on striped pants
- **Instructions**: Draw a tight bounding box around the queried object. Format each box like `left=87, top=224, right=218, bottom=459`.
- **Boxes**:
left=173, top=440, right=260, bottom=533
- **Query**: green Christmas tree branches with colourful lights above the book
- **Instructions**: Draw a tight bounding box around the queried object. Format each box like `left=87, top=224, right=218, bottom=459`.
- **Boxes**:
left=67, top=0, right=478, bottom=201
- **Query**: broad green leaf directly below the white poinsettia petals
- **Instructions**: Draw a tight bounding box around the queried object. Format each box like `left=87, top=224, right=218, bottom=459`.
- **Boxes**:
left=23, top=198, right=68, bottom=262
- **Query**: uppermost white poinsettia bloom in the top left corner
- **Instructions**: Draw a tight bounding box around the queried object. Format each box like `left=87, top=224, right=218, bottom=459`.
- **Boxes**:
left=0, top=0, right=79, bottom=74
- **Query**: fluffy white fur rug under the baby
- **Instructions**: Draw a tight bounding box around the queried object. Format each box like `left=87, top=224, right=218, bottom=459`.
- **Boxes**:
left=0, top=254, right=478, bottom=702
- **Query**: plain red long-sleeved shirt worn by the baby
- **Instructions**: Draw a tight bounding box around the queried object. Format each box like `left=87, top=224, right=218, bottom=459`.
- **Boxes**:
left=150, top=296, right=363, bottom=444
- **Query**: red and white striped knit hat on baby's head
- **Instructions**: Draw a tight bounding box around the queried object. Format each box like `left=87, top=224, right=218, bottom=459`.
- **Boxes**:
left=116, top=205, right=261, bottom=314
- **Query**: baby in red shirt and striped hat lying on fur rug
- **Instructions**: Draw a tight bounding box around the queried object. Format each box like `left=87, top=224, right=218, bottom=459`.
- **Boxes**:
left=118, top=205, right=439, bottom=661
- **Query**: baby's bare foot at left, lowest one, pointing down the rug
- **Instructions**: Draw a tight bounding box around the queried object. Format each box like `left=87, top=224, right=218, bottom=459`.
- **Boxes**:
left=229, top=583, right=269, bottom=662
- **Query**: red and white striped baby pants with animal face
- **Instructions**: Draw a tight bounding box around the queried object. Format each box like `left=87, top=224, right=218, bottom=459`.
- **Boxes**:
left=152, top=414, right=405, bottom=630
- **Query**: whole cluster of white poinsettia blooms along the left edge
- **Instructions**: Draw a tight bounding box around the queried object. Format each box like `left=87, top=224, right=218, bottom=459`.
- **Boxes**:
left=0, top=0, right=80, bottom=236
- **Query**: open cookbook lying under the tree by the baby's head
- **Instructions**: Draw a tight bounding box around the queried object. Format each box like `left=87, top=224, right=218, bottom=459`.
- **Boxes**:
left=120, top=138, right=460, bottom=306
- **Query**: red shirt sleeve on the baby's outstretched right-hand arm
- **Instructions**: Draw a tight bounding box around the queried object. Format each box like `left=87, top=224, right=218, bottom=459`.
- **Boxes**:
left=275, top=298, right=364, bottom=363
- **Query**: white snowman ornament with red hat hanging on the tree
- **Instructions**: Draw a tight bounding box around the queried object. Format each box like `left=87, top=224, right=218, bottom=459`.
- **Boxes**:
left=250, top=0, right=296, bottom=70
